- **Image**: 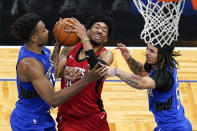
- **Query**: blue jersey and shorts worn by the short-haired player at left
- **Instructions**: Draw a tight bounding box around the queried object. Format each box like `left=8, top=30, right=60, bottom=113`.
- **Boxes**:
left=10, top=45, right=55, bottom=130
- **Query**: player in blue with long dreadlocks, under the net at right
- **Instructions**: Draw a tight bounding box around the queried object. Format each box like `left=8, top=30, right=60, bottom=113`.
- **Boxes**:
left=101, top=43, right=192, bottom=131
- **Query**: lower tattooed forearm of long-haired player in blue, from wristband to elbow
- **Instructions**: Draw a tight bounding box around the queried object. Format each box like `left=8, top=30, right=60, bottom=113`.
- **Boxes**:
left=117, top=70, right=154, bottom=89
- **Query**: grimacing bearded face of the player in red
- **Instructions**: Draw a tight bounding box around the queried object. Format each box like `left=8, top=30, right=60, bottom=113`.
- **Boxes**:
left=87, top=22, right=108, bottom=46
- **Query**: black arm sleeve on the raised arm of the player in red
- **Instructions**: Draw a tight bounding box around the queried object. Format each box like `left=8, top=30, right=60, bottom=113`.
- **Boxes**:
left=85, top=49, right=99, bottom=69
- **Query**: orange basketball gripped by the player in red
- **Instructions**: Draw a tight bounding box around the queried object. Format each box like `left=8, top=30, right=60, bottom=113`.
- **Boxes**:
left=53, top=18, right=80, bottom=46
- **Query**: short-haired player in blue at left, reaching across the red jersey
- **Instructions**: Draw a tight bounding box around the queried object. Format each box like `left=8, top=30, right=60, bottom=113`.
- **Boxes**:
left=10, top=13, right=106, bottom=131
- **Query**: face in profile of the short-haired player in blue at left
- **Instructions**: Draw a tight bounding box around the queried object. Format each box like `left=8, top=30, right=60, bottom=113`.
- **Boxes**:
left=36, top=21, right=49, bottom=46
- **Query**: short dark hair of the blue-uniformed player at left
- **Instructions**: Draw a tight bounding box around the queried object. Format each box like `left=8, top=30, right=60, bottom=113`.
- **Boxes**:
left=11, top=13, right=40, bottom=42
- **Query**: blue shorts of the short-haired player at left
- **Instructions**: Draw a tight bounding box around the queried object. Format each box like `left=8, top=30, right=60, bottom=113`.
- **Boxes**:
left=10, top=108, right=56, bottom=131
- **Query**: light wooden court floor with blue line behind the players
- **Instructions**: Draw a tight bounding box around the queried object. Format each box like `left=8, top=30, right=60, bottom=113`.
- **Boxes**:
left=0, top=47, right=197, bottom=131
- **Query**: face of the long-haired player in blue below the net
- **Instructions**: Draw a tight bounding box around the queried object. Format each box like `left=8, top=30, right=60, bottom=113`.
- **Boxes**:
left=146, top=44, right=158, bottom=65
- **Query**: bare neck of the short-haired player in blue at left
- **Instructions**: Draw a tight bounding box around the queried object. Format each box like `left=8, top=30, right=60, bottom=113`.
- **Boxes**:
left=26, top=42, right=42, bottom=54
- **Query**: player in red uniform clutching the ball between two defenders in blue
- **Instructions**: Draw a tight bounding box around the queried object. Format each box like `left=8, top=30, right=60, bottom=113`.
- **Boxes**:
left=56, top=13, right=113, bottom=131
